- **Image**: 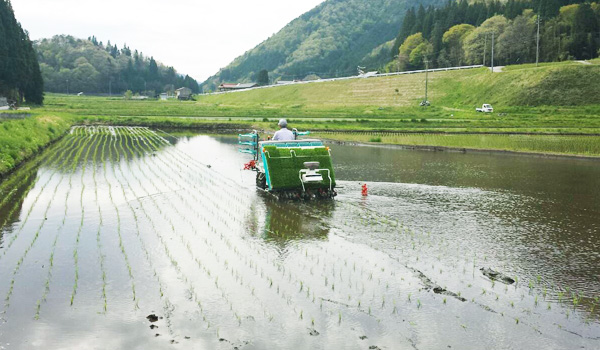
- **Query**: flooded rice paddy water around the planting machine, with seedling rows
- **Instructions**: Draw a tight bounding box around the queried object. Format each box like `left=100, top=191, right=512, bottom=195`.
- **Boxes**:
left=0, top=127, right=600, bottom=349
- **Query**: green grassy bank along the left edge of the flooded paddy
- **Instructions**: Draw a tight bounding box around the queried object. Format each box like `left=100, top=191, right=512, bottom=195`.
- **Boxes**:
left=0, top=115, right=72, bottom=179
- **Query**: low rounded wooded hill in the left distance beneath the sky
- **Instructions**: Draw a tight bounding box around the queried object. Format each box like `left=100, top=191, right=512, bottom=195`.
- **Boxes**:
left=34, top=35, right=198, bottom=95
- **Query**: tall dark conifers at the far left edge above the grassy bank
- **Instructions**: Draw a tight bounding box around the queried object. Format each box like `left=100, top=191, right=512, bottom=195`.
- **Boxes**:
left=0, top=0, right=44, bottom=104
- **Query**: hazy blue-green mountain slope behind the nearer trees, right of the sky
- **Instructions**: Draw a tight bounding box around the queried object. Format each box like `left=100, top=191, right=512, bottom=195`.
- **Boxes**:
left=203, top=0, right=446, bottom=90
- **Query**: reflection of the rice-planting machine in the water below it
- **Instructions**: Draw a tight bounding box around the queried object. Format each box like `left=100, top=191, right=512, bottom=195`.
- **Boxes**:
left=248, top=196, right=335, bottom=245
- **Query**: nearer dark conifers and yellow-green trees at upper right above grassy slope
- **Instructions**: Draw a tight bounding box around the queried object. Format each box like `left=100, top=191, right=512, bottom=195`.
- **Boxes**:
left=384, top=0, right=600, bottom=71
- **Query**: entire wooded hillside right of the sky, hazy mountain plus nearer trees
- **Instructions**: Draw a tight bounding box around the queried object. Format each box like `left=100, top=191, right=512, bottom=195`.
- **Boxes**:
left=203, top=0, right=600, bottom=90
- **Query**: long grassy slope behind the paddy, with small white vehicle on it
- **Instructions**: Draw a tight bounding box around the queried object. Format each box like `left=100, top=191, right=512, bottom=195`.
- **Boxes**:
left=37, top=62, right=600, bottom=134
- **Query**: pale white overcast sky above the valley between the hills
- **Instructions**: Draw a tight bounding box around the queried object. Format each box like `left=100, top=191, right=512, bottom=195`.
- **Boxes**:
left=11, top=0, right=323, bottom=82
